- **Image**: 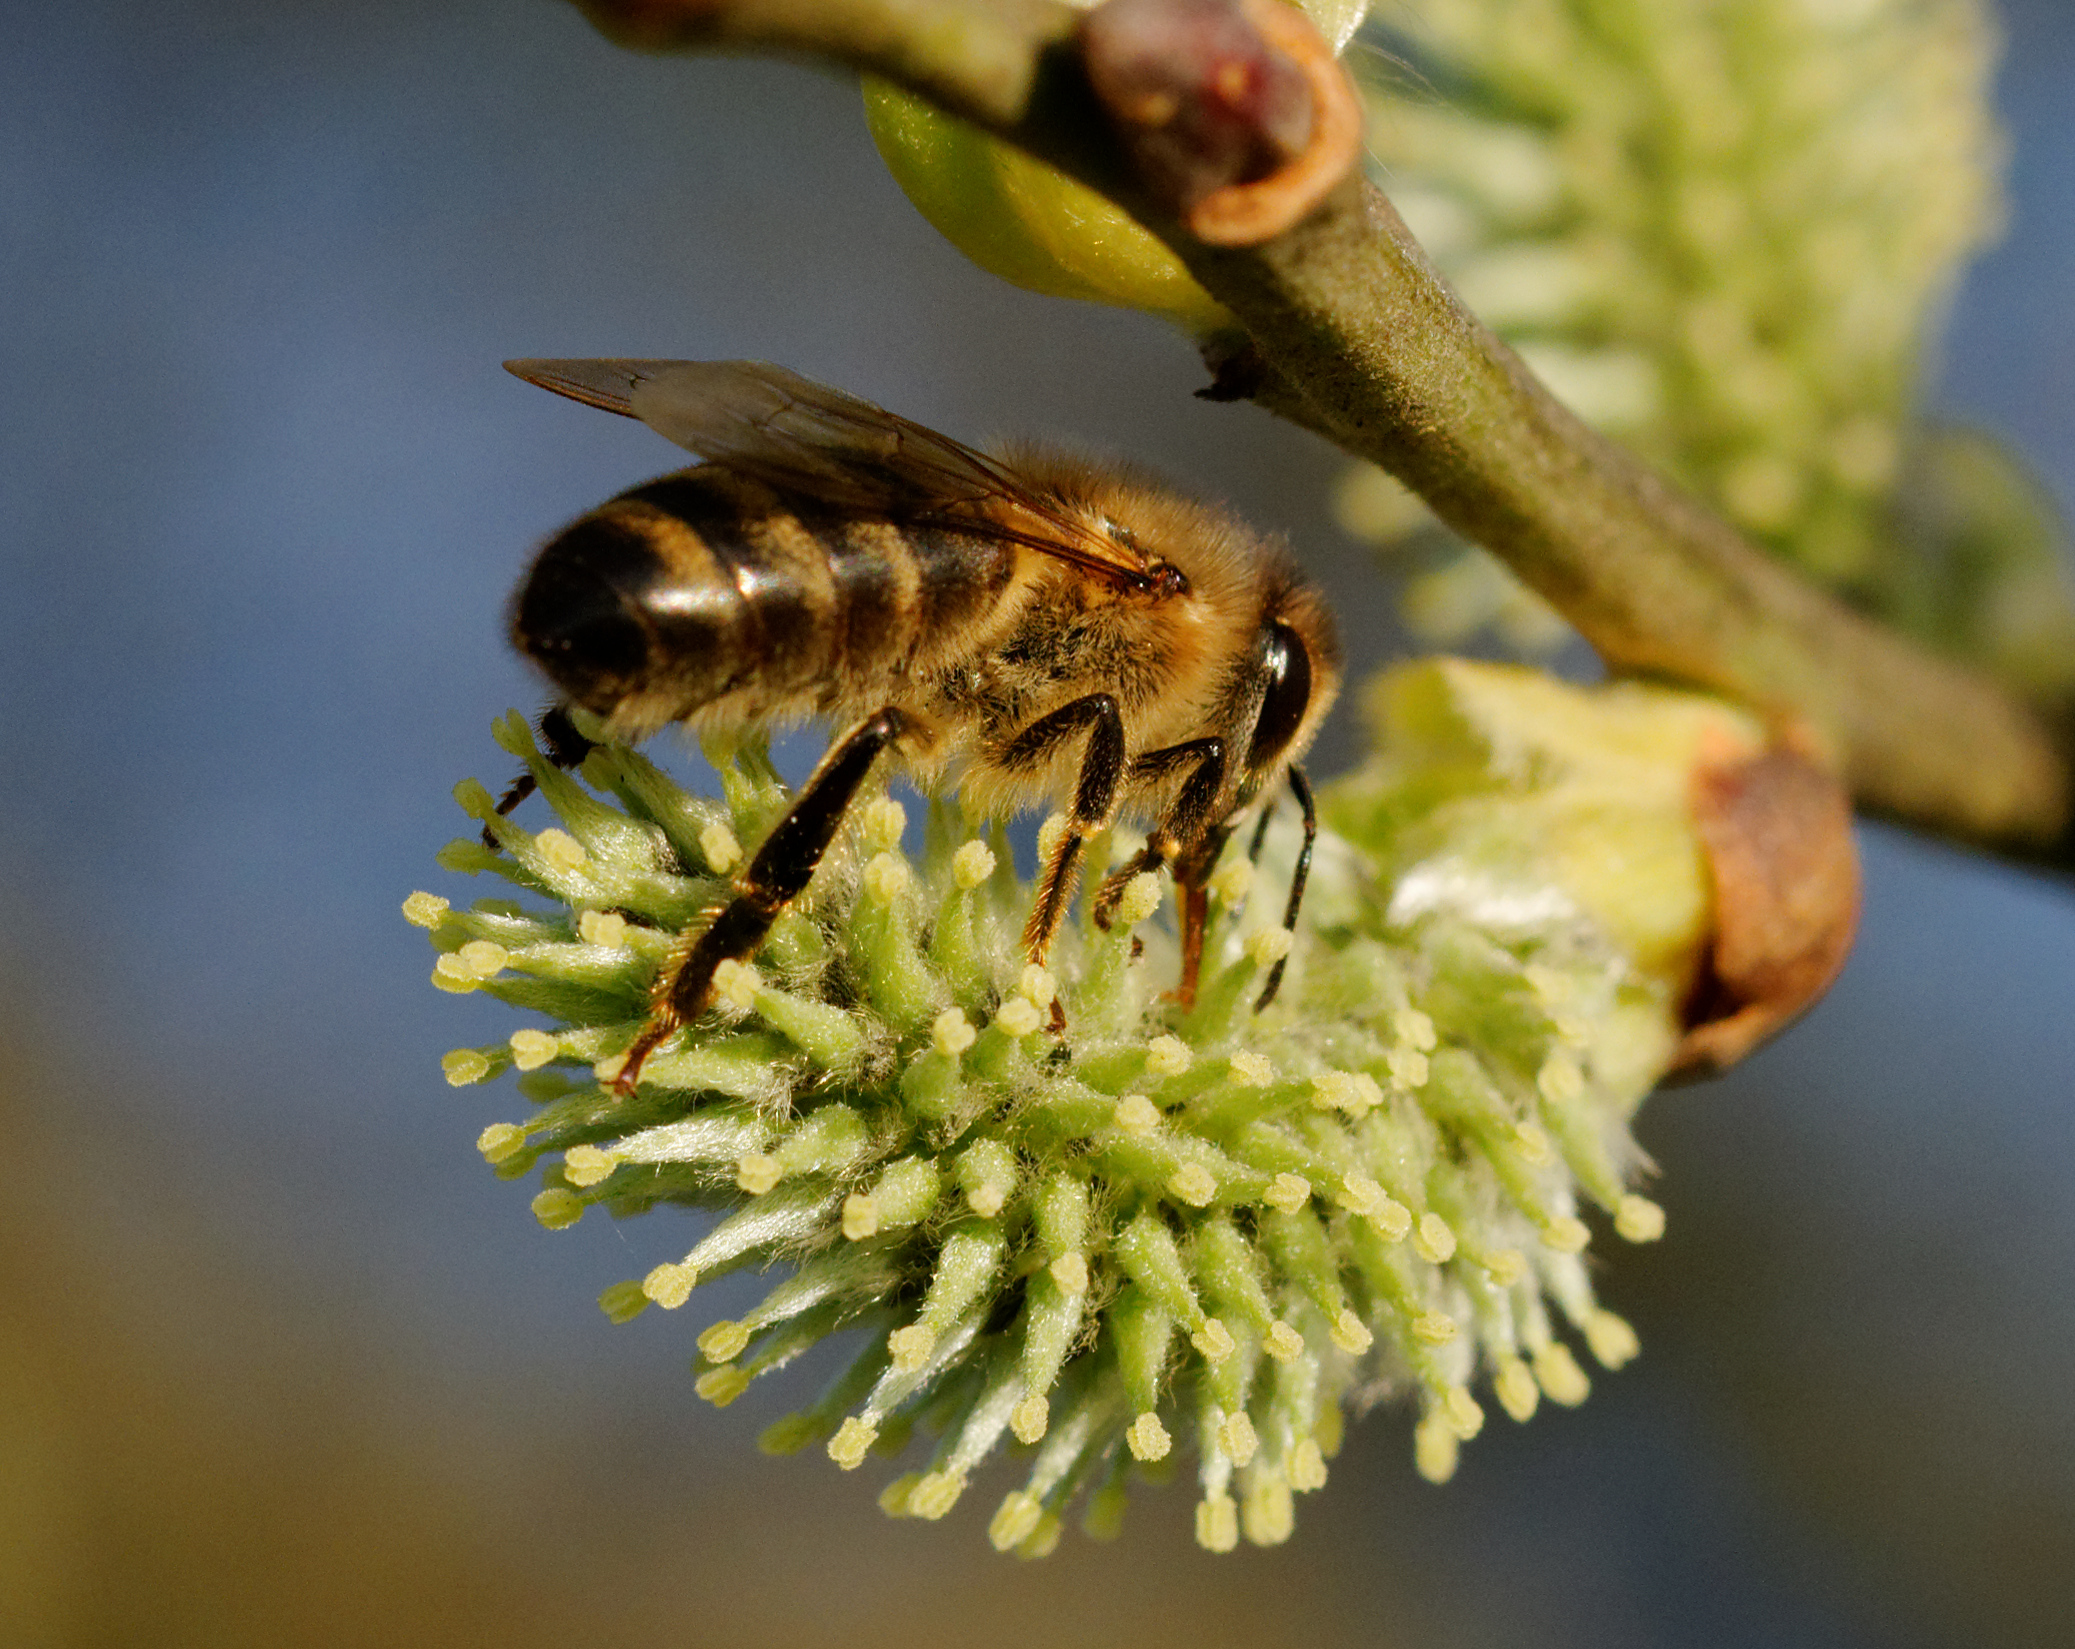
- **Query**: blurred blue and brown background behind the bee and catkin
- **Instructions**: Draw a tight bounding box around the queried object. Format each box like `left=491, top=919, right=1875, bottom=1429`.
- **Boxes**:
left=0, top=0, right=2075, bottom=1649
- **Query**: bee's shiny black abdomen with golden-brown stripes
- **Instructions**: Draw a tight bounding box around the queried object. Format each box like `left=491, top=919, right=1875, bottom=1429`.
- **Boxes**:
left=513, top=467, right=1015, bottom=734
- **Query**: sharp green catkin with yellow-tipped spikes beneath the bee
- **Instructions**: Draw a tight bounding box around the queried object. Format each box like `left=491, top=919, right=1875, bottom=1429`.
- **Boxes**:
left=425, top=667, right=1718, bottom=1556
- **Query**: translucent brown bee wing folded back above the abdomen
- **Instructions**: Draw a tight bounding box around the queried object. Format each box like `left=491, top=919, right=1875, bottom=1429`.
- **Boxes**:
left=504, top=361, right=1147, bottom=585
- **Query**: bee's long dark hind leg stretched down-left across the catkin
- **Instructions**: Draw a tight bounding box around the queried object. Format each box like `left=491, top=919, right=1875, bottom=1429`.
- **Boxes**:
left=612, top=707, right=911, bottom=1097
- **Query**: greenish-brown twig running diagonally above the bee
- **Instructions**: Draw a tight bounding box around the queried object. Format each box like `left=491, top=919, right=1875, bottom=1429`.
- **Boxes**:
left=579, top=0, right=2075, bottom=853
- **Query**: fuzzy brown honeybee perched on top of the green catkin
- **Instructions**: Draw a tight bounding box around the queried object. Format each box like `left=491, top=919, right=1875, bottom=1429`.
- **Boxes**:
left=506, top=361, right=1340, bottom=1093
